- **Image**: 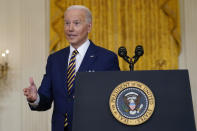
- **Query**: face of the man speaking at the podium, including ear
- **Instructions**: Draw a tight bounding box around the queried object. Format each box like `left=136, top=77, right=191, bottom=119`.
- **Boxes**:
left=64, top=9, right=91, bottom=48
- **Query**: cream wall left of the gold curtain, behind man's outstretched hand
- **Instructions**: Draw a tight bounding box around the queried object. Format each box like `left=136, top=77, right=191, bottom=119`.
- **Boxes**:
left=0, top=0, right=51, bottom=131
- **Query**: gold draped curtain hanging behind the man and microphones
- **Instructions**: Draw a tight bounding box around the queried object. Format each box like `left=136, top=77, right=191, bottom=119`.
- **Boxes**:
left=50, top=0, right=181, bottom=70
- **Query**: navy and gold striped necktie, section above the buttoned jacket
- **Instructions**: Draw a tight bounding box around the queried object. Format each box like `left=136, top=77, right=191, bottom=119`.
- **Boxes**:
left=67, top=50, right=79, bottom=94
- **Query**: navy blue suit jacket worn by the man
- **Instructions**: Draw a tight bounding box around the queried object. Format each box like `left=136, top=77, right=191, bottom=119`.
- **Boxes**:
left=30, top=41, right=120, bottom=131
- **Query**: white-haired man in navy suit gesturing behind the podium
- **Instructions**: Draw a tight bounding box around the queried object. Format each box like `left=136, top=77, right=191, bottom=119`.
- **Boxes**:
left=24, top=5, right=120, bottom=131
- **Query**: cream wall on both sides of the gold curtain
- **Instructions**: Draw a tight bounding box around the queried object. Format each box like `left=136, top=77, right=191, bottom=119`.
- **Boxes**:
left=0, top=0, right=197, bottom=131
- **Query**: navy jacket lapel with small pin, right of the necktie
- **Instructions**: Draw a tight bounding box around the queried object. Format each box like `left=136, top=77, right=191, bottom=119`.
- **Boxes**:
left=78, top=41, right=96, bottom=72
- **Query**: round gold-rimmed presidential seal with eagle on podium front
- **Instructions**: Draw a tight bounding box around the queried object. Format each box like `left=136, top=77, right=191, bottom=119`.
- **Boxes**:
left=109, top=81, right=155, bottom=125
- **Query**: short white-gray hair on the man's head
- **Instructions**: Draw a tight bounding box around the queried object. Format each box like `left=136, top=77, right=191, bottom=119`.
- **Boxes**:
left=66, top=5, right=92, bottom=23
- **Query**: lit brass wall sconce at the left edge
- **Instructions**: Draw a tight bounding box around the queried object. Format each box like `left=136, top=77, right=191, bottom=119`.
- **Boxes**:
left=0, top=50, right=10, bottom=79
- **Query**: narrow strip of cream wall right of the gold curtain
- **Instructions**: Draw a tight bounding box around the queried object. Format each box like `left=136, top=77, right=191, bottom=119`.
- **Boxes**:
left=179, top=0, right=197, bottom=125
